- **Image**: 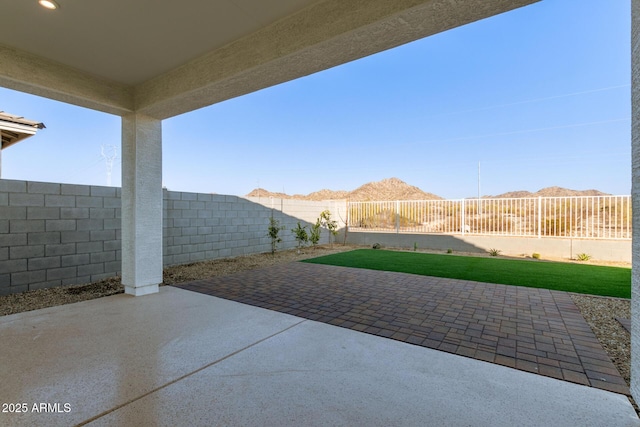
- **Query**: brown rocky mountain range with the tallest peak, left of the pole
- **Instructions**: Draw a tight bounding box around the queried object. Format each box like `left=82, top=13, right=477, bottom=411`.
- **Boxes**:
left=247, top=178, right=442, bottom=202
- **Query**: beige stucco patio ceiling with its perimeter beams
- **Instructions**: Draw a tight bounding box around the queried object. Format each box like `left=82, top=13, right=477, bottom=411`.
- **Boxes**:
left=0, top=0, right=537, bottom=119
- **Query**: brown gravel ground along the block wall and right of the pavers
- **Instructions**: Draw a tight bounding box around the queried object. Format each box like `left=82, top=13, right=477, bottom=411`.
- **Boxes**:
left=0, top=245, right=631, bottom=402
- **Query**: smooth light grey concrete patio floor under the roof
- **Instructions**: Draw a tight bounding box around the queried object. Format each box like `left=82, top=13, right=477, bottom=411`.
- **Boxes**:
left=0, top=287, right=640, bottom=426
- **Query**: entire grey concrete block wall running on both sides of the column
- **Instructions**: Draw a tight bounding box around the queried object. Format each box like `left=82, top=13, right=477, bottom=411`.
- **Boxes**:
left=0, top=180, right=344, bottom=295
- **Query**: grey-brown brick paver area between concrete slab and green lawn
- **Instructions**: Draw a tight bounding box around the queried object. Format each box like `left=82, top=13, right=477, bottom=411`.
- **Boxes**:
left=172, top=262, right=629, bottom=395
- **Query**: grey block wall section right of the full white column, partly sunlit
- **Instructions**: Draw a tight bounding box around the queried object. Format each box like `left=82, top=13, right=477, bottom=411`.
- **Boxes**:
left=163, top=191, right=346, bottom=266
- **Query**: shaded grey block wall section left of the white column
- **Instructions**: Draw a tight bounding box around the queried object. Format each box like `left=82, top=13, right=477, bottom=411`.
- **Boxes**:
left=0, top=180, right=122, bottom=295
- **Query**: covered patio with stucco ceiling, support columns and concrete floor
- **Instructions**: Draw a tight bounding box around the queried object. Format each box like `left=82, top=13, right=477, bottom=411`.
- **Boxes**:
left=0, top=0, right=640, bottom=425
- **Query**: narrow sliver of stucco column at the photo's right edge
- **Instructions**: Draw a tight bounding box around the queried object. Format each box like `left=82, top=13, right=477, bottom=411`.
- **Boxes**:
left=631, top=0, right=640, bottom=402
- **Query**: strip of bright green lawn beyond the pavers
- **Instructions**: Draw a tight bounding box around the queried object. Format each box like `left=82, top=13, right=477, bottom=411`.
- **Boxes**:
left=303, top=249, right=631, bottom=298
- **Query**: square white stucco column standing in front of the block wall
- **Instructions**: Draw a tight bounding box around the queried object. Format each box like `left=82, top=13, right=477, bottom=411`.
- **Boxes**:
left=122, top=113, right=162, bottom=296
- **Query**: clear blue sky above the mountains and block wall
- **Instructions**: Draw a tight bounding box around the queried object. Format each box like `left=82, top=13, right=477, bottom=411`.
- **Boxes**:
left=0, top=0, right=631, bottom=198
